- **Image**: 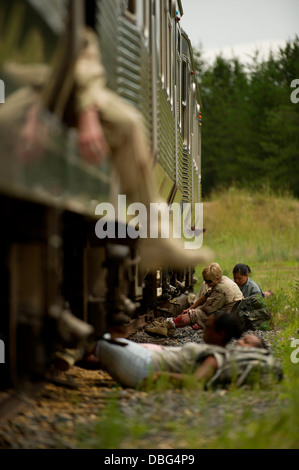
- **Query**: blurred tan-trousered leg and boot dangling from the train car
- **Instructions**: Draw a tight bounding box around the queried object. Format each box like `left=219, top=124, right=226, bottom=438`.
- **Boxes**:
left=85, top=90, right=212, bottom=269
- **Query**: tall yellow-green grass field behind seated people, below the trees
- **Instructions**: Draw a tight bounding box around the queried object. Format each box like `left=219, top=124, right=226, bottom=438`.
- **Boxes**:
left=204, top=188, right=299, bottom=268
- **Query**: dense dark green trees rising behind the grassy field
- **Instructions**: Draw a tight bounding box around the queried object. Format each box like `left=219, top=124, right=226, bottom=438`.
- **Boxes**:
left=194, top=36, right=299, bottom=197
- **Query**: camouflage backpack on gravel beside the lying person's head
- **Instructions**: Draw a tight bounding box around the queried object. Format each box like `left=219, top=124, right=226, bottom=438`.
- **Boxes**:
left=206, top=346, right=283, bottom=388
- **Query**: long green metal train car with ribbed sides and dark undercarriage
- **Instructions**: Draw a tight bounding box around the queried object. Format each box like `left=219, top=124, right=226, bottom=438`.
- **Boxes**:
left=0, top=0, right=201, bottom=386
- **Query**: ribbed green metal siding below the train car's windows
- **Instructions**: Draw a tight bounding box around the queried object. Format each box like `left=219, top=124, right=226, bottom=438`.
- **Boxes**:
left=98, top=0, right=200, bottom=202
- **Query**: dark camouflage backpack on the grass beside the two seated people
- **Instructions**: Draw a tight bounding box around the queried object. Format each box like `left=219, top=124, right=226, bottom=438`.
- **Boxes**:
left=232, top=295, right=271, bottom=330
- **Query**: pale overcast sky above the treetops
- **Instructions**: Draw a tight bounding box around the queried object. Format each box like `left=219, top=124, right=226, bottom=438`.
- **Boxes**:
left=181, top=0, right=299, bottom=62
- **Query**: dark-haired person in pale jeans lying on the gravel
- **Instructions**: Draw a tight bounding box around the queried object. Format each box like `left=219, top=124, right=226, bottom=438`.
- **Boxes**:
left=83, top=311, right=270, bottom=388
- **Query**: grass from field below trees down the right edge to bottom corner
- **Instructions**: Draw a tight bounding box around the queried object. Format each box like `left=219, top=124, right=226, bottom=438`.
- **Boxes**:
left=197, top=188, right=299, bottom=449
